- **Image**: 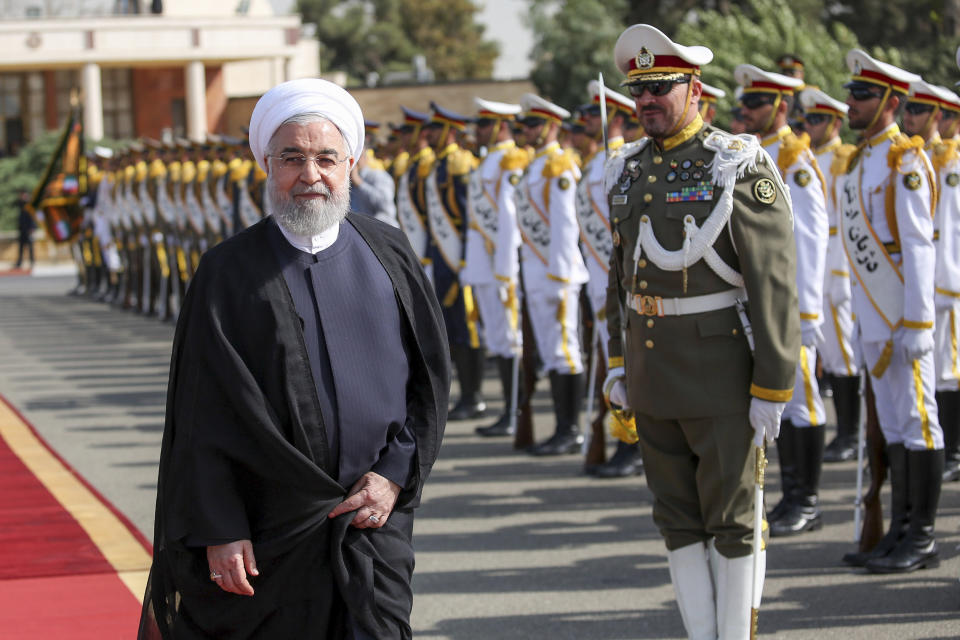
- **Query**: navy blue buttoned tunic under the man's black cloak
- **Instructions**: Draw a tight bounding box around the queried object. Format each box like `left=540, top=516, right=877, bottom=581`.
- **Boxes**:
left=271, top=224, right=416, bottom=488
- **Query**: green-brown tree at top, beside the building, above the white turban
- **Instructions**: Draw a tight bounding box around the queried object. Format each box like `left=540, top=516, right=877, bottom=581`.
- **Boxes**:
left=297, top=0, right=499, bottom=82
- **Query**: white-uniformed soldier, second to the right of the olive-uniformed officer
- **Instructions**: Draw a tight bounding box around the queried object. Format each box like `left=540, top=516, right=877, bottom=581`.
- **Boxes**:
left=796, top=87, right=862, bottom=462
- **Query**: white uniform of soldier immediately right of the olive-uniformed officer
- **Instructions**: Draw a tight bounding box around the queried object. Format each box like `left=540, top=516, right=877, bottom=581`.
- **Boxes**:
left=761, top=127, right=830, bottom=427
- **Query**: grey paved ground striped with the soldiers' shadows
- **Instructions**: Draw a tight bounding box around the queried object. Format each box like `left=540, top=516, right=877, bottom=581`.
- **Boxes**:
left=0, top=276, right=960, bottom=640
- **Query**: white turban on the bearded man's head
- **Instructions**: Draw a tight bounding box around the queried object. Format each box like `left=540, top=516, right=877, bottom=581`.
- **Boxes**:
left=250, top=78, right=364, bottom=171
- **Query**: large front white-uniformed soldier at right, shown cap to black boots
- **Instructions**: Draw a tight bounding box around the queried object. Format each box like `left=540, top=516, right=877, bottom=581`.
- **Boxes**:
left=837, top=49, right=943, bottom=573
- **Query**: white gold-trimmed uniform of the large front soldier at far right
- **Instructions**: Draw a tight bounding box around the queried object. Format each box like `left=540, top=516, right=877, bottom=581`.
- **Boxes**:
left=841, top=124, right=943, bottom=451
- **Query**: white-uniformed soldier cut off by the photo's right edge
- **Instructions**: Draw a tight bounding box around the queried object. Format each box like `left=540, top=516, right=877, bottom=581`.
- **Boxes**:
left=903, top=80, right=960, bottom=483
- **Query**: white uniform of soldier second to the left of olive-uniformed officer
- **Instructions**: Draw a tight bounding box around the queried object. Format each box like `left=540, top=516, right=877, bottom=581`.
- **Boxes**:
left=516, top=137, right=589, bottom=374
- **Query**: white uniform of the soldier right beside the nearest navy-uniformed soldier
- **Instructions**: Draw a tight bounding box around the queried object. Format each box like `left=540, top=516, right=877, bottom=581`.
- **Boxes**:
left=460, top=140, right=518, bottom=358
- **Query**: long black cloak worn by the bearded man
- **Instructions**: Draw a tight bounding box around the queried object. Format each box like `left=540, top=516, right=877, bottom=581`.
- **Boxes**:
left=139, top=214, right=450, bottom=638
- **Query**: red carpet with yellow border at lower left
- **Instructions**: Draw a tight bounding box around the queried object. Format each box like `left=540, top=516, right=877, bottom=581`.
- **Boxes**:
left=0, top=396, right=150, bottom=640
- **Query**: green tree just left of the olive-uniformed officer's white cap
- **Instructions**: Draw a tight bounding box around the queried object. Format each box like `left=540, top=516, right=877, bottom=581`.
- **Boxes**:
left=529, top=0, right=627, bottom=108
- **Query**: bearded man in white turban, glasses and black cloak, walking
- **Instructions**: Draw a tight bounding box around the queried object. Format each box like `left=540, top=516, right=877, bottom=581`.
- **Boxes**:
left=140, top=79, right=450, bottom=639
